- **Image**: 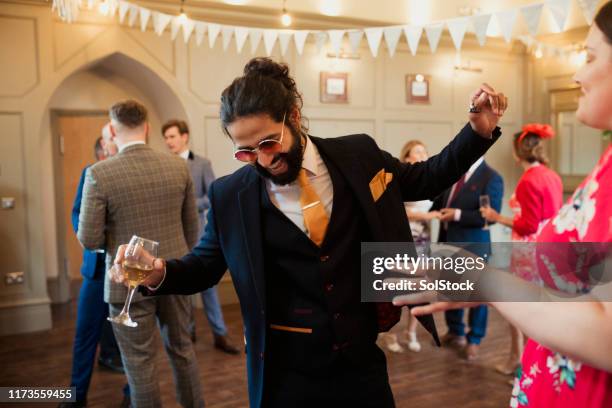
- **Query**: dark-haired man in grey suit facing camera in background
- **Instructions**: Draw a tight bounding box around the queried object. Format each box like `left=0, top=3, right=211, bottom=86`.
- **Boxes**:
left=162, top=119, right=240, bottom=354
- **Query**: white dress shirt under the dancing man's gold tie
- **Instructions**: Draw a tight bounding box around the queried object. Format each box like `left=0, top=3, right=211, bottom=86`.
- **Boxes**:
left=266, top=136, right=334, bottom=233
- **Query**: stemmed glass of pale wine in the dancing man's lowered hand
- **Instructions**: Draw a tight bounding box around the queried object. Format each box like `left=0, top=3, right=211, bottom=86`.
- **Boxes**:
left=108, top=235, right=159, bottom=327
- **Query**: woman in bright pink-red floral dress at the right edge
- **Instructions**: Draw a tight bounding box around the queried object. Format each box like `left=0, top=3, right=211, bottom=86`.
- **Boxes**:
left=397, top=1, right=612, bottom=408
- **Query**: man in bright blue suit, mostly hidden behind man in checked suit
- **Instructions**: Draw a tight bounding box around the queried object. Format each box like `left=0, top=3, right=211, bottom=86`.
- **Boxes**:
left=60, top=125, right=129, bottom=407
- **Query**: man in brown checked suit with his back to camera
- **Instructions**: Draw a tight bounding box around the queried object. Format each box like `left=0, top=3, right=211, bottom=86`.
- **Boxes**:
left=77, top=101, right=204, bottom=407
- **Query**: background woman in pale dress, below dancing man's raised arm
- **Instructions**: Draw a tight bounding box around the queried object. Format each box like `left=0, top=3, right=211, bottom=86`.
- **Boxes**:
left=380, top=140, right=441, bottom=353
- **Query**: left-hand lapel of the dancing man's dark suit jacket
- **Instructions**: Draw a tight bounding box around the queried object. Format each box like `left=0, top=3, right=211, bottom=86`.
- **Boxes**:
left=238, top=171, right=266, bottom=307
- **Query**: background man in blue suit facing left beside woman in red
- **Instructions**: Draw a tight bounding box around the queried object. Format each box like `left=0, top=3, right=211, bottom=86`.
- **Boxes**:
left=432, top=157, right=504, bottom=360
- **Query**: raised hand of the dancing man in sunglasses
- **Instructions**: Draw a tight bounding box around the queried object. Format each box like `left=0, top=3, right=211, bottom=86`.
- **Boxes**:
left=469, top=83, right=508, bottom=138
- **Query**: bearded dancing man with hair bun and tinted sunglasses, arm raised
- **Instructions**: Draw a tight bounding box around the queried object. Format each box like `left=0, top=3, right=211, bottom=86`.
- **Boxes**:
left=113, top=58, right=507, bottom=408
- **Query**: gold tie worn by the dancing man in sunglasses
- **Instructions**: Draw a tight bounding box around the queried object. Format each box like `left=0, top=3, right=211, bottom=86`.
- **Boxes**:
left=298, top=169, right=329, bottom=246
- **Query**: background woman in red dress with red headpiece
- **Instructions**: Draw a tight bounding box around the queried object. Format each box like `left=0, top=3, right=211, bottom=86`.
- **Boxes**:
left=480, top=124, right=563, bottom=375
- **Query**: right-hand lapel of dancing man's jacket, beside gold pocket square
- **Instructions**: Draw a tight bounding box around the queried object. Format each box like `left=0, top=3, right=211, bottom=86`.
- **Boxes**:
left=309, top=136, right=385, bottom=241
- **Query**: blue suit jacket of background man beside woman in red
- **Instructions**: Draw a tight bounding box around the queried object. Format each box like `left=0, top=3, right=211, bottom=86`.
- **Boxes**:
left=432, top=161, right=504, bottom=256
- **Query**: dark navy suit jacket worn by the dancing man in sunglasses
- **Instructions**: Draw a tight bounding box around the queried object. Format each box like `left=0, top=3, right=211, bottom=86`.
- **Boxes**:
left=149, top=125, right=501, bottom=408
